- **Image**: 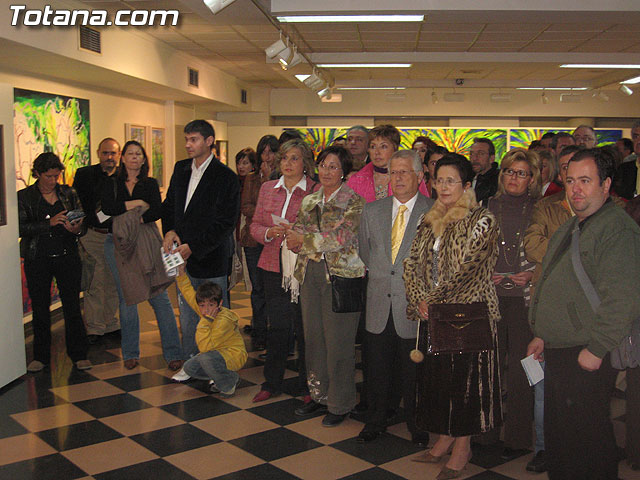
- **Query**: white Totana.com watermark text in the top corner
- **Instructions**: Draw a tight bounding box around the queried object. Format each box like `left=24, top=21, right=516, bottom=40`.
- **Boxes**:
left=9, top=5, right=180, bottom=27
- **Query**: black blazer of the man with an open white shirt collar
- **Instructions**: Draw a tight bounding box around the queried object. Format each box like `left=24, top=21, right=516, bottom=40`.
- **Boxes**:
left=162, top=157, right=240, bottom=278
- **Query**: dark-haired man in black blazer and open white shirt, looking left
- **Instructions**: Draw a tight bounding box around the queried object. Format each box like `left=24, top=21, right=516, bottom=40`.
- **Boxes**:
left=162, top=120, right=240, bottom=359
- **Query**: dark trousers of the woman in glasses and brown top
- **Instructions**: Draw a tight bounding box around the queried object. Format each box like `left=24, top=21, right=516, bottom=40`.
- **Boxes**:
left=495, top=296, right=533, bottom=449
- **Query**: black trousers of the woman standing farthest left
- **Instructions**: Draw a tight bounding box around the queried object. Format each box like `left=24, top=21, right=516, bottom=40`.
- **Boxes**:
left=24, top=253, right=89, bottom=364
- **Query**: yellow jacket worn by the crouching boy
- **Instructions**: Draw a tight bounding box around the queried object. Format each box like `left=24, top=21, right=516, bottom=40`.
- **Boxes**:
left=178, top=274, right=248, bottom=371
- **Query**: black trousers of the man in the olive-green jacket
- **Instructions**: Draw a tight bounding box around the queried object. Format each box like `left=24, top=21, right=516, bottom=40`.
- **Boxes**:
left=544, top=347, right=618, bottom=480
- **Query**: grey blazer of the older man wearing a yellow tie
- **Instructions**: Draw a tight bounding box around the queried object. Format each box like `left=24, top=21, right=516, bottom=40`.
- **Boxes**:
left=359, top=193, right=433, bottom=338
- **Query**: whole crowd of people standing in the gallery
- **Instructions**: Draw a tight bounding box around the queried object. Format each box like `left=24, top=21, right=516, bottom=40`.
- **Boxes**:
left=18, top=120, right=640, bottom=480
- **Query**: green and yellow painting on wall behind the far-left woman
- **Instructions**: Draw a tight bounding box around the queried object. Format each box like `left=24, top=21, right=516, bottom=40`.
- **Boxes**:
left=13, top=88, right=91, bottom=190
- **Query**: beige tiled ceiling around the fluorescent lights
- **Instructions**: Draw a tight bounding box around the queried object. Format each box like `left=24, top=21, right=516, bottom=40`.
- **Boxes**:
left=72, top=0, right=640, bottom=92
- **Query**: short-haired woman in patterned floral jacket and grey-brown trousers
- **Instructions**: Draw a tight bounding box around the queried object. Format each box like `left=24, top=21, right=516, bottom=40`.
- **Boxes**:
left=286, top=146, right=365, bottom=427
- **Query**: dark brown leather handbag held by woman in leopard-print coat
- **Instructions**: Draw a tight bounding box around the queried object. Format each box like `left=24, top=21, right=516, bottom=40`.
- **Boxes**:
left=423, top=302, right=493, bottom=355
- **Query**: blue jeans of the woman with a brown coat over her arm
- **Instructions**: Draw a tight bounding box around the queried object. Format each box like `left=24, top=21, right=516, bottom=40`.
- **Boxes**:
left=104, top=234, right=182, bottom=363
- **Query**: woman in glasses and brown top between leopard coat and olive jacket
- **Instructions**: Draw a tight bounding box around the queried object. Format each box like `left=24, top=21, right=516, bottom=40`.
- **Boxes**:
left=489, top=148, right=542, bottom=460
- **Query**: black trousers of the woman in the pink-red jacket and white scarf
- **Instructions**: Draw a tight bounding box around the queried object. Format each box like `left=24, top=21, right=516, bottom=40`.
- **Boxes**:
left=258, top=268, right=308, bottom=395
